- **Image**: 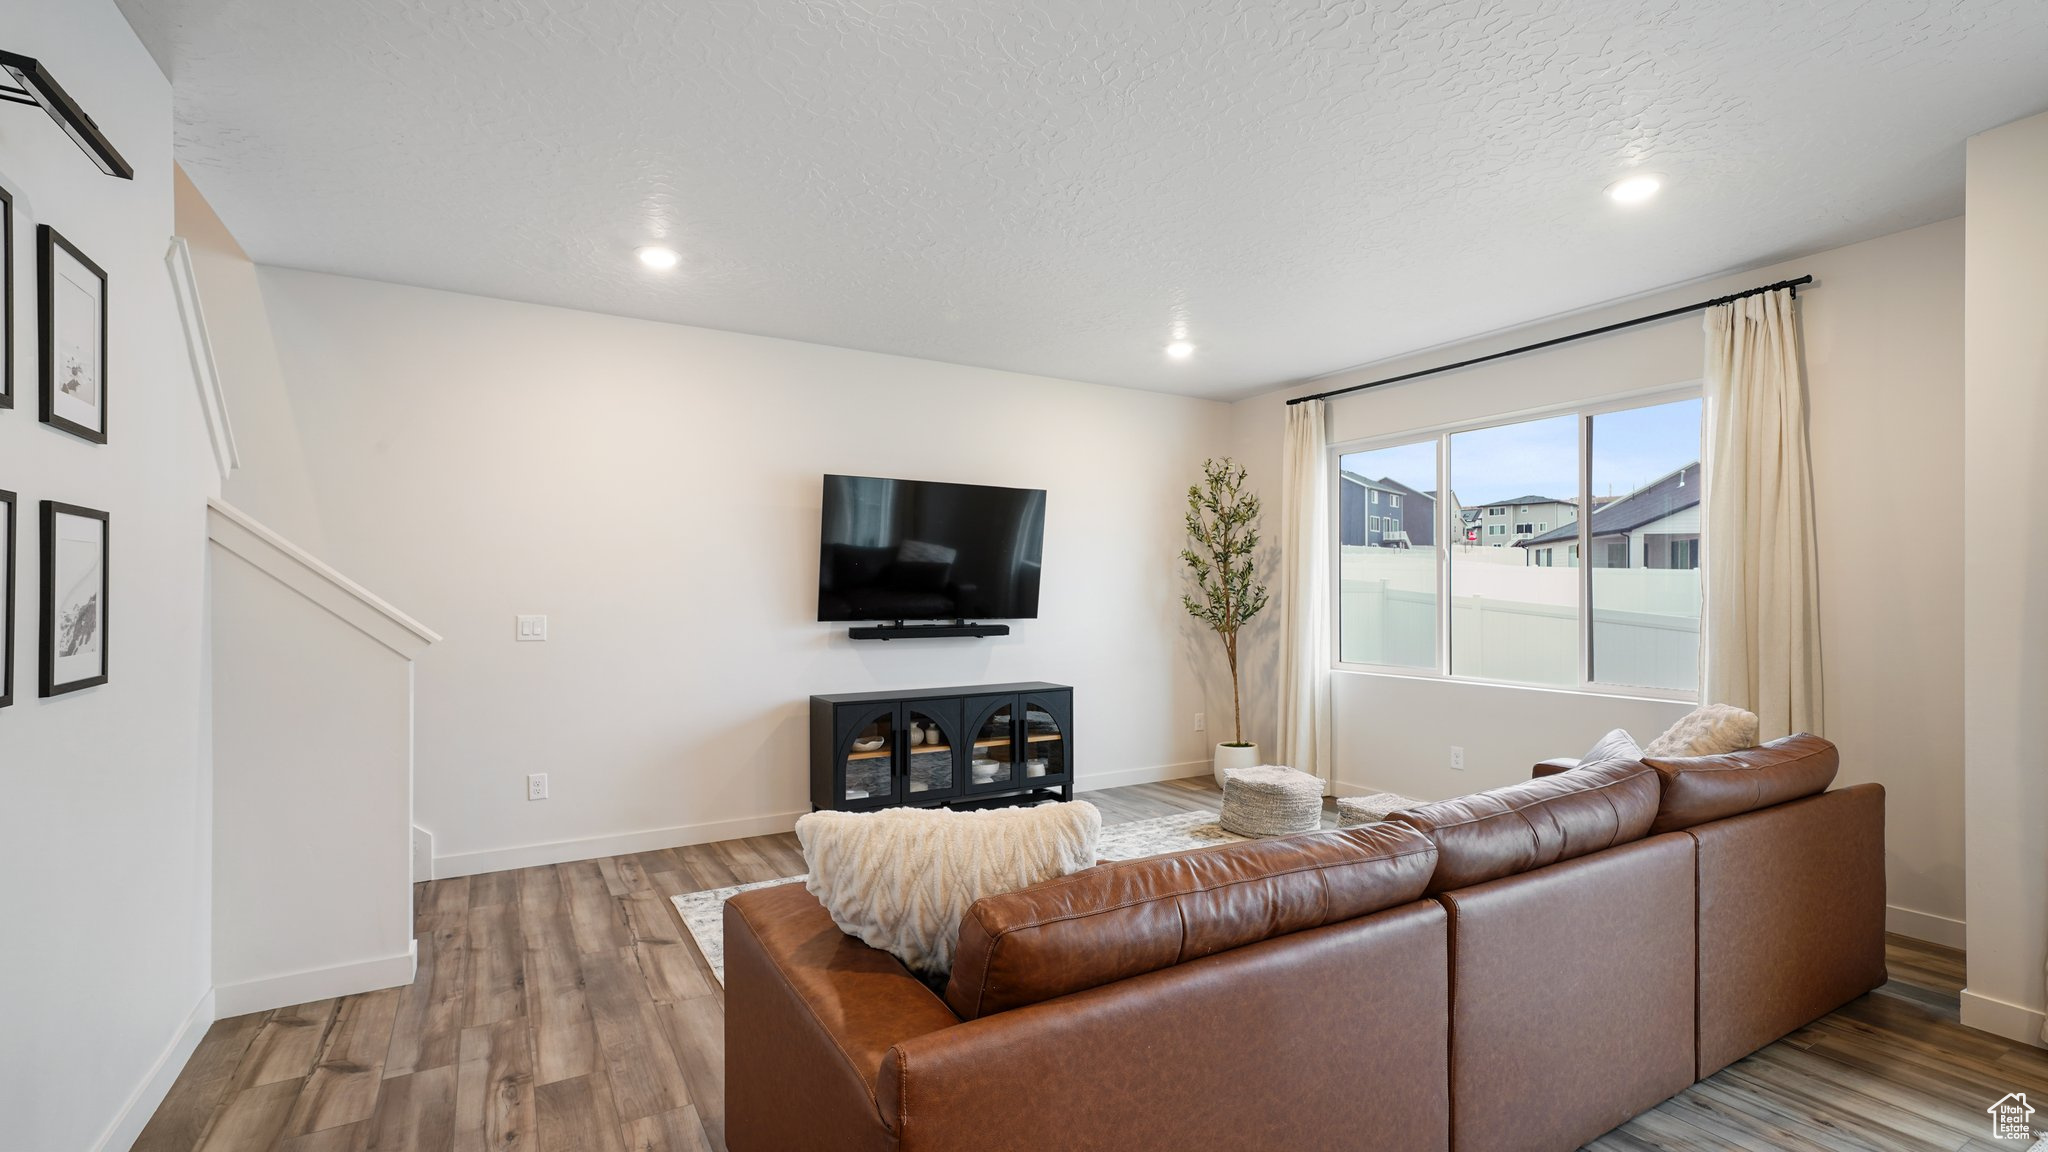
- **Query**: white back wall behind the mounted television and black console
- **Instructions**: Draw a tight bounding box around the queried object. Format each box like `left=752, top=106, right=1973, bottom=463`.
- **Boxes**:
left=243, top=269, right=1227, bottom=873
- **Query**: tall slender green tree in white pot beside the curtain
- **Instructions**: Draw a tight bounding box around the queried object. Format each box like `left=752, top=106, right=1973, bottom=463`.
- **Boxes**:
left=1180, top=457, right=1266, bottom=785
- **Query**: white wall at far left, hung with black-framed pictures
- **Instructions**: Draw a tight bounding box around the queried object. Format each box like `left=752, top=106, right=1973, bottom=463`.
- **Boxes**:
left=0, top=0, right=215, bottom=1150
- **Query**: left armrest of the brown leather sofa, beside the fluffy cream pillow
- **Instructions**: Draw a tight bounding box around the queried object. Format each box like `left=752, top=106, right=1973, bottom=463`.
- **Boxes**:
left=725, top=883, right=961, bottom=1152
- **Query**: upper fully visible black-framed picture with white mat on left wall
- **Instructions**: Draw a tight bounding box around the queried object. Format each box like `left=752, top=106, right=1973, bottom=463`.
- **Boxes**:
left=35, top=223, right=106, bottom=445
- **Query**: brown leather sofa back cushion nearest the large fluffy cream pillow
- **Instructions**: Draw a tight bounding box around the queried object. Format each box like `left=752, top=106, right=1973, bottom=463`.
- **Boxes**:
left=946, top=824, right=1436, bottom=1021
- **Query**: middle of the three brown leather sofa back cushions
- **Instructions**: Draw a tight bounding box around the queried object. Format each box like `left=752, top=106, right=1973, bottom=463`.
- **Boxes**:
left=1389, top=758, right=1657, bottom=892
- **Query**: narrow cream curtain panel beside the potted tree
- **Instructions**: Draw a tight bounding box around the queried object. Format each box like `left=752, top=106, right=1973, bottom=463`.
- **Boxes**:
left=1274, top=400, right=1335, bottom=785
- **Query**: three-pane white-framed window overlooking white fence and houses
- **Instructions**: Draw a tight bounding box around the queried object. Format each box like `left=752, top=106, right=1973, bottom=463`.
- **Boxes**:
left=1335, top=396, right=1704, bottom=695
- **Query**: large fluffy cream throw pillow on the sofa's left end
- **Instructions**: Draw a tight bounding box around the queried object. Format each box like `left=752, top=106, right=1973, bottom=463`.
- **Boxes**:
left=797, top=801, right=1102, bottom=980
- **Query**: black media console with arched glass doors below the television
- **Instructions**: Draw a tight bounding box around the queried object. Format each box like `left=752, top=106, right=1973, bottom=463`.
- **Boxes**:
left=811, top=683, right=1073, bottom=812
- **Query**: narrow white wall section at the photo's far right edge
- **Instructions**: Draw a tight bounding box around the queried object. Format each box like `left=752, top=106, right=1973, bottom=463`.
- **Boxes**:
left=1962, top=115, right=2048, bottom=1043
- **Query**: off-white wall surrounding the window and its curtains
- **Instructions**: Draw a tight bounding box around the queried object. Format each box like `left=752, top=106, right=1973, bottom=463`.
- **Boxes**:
left=1233, top=219, right=1966, bottom=942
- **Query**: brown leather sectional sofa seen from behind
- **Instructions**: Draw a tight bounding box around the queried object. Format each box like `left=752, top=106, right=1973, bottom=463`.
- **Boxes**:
left=725, top=736, right=1884, bottom=1152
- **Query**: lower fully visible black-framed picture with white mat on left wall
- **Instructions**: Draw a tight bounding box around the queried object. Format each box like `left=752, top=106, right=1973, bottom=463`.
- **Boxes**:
left=41, top=500, right=109, bottom=697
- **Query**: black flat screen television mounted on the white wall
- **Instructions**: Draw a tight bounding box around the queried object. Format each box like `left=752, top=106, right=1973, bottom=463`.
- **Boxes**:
left=817, top=476, right=1044, bottom=621
